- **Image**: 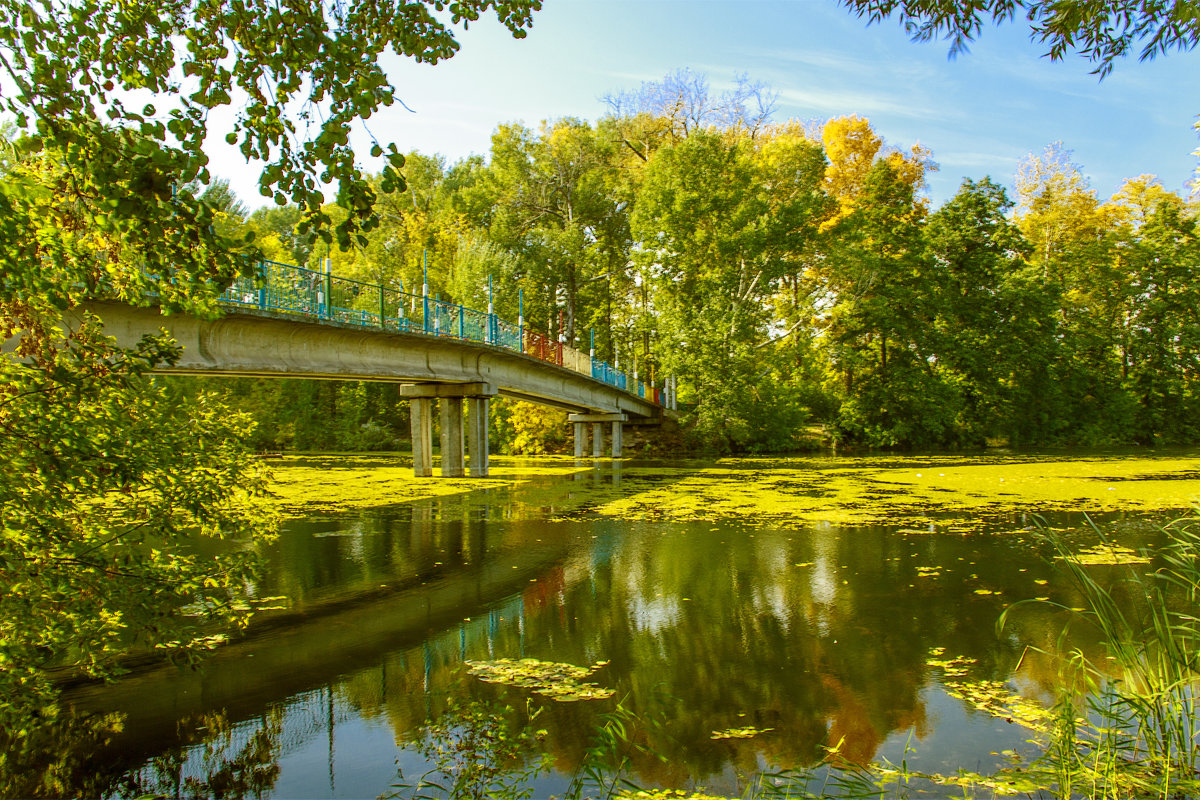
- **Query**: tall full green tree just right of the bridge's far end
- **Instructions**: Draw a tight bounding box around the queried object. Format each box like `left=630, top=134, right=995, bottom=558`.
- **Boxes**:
left=634, top=130, right=824, bottom=449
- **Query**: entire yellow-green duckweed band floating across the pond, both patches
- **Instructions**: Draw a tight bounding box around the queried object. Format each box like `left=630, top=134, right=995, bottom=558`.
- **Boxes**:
left=271, top=453, right=1200, bottom=527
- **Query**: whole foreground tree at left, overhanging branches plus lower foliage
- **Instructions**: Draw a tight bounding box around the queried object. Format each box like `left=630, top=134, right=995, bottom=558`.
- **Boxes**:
left=0, top=0, right=541, bottom=783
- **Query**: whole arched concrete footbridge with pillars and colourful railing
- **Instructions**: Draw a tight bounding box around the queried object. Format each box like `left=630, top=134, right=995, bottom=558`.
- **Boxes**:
left=76, top=280, right=673, bottom=477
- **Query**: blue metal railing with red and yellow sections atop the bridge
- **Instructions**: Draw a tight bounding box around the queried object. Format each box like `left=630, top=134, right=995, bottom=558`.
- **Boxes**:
left=220, top=260, right=658, bottom=402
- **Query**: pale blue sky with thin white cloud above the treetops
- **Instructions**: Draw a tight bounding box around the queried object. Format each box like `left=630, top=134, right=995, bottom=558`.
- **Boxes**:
left=214, top=0, right=1200, bottom=204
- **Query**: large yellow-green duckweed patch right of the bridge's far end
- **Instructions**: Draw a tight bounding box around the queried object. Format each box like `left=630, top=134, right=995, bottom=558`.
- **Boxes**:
left=595, top=456, right=1200, bottom=534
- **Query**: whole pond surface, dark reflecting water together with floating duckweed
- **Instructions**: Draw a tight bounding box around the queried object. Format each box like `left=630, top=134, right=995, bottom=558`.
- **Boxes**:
left=60, top=452, right=1200, bottom=798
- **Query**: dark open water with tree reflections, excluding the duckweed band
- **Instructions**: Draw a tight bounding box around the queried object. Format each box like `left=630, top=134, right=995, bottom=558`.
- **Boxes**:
left=60, top=453, right=1195, bottom=798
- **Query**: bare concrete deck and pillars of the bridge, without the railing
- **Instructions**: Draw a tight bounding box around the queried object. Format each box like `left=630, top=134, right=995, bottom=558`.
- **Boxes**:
left=75, top=303, right=661, bottom=476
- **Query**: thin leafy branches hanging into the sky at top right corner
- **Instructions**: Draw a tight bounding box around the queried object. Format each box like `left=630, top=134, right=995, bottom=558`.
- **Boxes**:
left=841, top=0, right=1200, bottom=77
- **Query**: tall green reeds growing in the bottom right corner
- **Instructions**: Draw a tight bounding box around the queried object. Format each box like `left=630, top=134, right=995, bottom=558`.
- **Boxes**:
left=1000, top=513, right=1200, bottom=798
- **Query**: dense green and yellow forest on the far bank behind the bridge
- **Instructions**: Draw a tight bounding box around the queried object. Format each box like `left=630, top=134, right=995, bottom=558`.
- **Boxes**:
left=187, top=71, right=1200, bottom=452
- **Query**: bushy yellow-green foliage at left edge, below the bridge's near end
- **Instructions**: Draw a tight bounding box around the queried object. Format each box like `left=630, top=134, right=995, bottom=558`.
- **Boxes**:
left=0, top=317, right=274, bottom=778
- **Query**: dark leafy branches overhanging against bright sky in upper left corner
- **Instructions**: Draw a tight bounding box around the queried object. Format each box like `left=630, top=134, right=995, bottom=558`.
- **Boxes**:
left=0, top=0, right=541, bottom=246
